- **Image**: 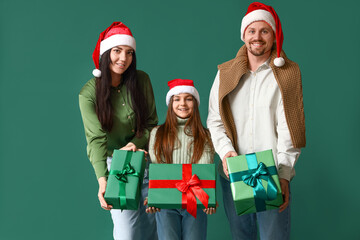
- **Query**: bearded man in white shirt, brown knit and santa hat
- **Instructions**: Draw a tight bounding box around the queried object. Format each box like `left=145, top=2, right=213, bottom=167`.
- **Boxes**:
left=207, top=2, right=306, bottom=240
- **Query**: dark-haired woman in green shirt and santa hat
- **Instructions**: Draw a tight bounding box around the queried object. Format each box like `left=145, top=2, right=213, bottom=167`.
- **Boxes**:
left=79, top=22, right=158, bottom=239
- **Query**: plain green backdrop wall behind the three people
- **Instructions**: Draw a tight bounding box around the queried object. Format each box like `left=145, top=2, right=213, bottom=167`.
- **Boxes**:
left=0, top=0, right=360, bottom=240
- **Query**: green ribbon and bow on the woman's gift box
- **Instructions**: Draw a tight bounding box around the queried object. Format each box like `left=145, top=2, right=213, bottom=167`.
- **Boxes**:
left=109, top=152, right=142, bottom=209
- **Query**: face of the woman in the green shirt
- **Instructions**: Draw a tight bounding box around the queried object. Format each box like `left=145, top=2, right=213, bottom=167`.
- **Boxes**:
left=109, top=45, right=134, bottom=75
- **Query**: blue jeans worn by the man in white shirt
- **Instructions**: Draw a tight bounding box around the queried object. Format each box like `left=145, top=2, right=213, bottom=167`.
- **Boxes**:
left=220, top=176, right=291, bottom=240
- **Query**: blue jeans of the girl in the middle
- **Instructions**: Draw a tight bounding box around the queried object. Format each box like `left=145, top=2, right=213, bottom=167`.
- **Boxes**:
left=155, top=209, right=207, bottom=240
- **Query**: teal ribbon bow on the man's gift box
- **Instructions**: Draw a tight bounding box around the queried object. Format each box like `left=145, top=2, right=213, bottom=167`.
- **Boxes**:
left=241, top=162, right=278, bottom=201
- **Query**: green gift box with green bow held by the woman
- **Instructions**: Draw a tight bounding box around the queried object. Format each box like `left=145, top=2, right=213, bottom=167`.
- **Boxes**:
left=104, top=150, right=145, bottom=210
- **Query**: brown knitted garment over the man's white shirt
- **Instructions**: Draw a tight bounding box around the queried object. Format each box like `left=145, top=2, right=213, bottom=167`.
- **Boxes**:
left=218, top=45, right=306, bottom=152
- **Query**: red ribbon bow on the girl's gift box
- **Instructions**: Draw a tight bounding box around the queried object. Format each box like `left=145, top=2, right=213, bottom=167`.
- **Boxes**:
left=176, top=174, right=209, bottom=218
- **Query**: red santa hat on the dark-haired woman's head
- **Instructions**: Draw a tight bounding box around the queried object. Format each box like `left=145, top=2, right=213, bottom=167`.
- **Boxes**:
left=93, top=22, right=136, bottom=77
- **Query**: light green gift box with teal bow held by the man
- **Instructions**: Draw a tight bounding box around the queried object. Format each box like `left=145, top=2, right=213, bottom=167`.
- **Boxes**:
left=226, top=150, right=283, bottom=215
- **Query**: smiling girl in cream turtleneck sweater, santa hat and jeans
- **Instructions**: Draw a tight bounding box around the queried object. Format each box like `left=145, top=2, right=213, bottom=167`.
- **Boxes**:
left=145, top=79, right=216, bottom=240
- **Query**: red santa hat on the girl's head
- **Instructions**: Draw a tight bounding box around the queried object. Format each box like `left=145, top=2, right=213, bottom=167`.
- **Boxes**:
left=166, top=79, right=200, bottom=106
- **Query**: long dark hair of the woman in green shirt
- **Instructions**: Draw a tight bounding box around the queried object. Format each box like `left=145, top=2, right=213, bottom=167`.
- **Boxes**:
left=95, top=49, right=148, bottom=137
